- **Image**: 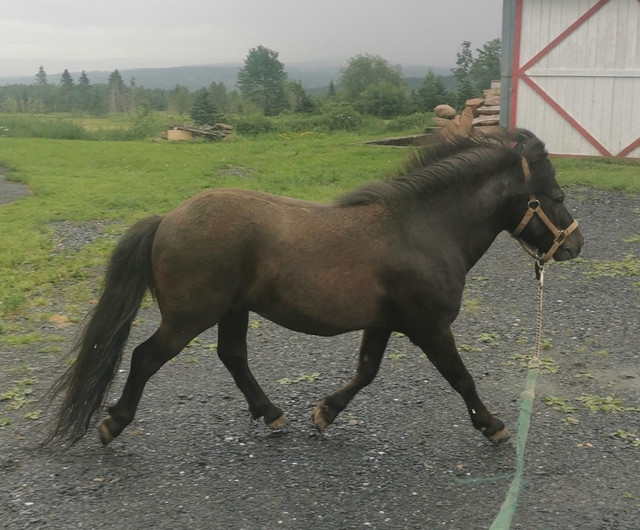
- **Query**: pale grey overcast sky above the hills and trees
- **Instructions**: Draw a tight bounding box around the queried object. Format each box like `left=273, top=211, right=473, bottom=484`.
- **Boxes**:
left=0, top=0, right=502, bottom=77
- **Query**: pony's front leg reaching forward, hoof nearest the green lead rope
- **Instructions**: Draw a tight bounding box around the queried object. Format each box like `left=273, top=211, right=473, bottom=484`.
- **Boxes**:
left=407, top=327, right=511, bottom=443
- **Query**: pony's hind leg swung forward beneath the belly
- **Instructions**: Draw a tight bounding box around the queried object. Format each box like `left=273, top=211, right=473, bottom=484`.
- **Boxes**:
left=218, top=310, right=289, bottom=429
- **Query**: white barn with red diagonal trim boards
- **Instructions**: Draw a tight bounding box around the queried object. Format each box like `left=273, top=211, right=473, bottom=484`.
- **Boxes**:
left=501, top=0, right=640, bottom=158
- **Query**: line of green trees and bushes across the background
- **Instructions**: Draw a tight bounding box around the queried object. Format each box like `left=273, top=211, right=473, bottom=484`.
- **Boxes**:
left=0, top=39, right=501, bottom=124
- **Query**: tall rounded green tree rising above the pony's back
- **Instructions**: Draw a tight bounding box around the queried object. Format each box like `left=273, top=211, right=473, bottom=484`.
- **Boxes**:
left=236, top=46, right=287, bottom=116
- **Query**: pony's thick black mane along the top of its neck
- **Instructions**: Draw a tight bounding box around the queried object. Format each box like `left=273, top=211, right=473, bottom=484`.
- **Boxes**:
left=336, top=129, right=547, bottom=206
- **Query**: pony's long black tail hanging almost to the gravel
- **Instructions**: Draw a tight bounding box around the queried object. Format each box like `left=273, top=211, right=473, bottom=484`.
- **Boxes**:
left=43, top=212, right=162, bottom=444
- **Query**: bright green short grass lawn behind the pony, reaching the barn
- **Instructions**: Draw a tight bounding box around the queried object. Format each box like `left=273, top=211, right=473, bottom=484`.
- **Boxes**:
left=0, top=133, right=640, bottom=328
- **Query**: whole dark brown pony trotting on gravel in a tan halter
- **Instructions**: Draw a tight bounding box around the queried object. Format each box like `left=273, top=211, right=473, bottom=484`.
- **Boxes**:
left=47, top=130, right=584, bottom=444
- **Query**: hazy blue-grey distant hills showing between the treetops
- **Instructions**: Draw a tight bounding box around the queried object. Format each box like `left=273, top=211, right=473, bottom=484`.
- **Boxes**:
left=0, top=62, right=451, bottom=92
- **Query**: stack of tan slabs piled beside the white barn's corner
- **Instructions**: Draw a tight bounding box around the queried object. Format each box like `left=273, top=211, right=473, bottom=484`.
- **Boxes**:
left=433, top=81, right=500, bottom=131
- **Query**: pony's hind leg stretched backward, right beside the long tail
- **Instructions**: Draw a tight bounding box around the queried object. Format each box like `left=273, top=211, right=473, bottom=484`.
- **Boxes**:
left=98, top=323, right=196, bottom=445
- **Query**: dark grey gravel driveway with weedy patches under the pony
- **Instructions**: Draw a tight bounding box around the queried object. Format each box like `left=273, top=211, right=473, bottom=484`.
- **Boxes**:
left=0, top=180, right=640, bottom=530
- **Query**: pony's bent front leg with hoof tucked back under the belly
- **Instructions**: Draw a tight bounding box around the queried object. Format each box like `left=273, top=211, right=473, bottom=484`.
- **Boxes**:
left=311, top=329, right=391, bottom=432
